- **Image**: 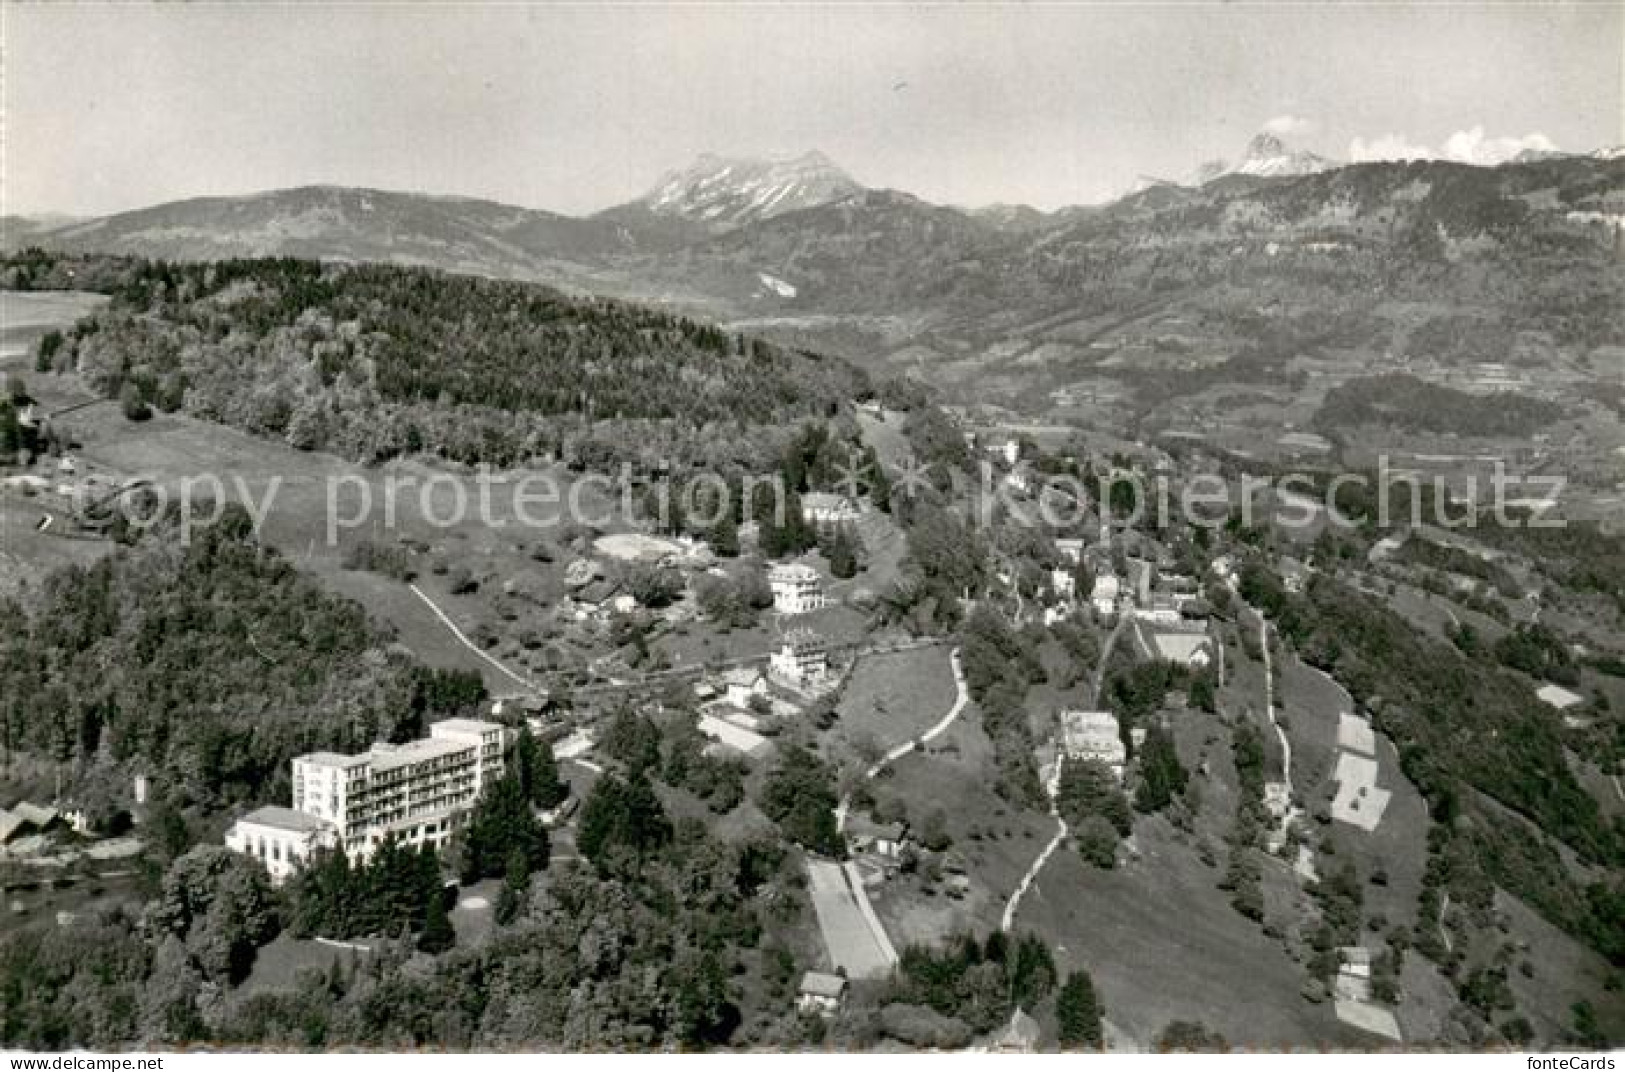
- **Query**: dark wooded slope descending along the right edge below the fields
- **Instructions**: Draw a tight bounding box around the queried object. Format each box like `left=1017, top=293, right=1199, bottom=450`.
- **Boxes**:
left=1242, top=565, right=1625, bottom=963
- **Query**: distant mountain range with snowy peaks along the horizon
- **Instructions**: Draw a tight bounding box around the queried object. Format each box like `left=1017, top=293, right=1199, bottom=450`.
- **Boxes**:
left=0, top=133, right=1625, bottom=402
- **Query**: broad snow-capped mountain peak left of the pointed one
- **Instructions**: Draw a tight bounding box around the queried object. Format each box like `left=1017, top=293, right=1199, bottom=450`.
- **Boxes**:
left=639, top=151, right=863, bottom=227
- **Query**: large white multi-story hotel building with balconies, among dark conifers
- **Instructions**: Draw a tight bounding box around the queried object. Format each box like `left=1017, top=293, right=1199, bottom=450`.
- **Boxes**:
left=226, top=718, right=507, bottom=880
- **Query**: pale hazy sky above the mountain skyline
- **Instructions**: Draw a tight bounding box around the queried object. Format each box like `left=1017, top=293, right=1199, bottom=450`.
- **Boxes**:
left=0, top=0, right=1625, bottom=213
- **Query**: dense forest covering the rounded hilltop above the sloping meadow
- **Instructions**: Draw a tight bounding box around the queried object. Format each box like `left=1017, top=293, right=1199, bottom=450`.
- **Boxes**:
left=9, top=250, right=871, bottom=471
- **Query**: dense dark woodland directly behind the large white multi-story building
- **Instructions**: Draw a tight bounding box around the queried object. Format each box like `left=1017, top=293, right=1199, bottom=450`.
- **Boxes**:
left=0, top=507, right=484, bottom=819
